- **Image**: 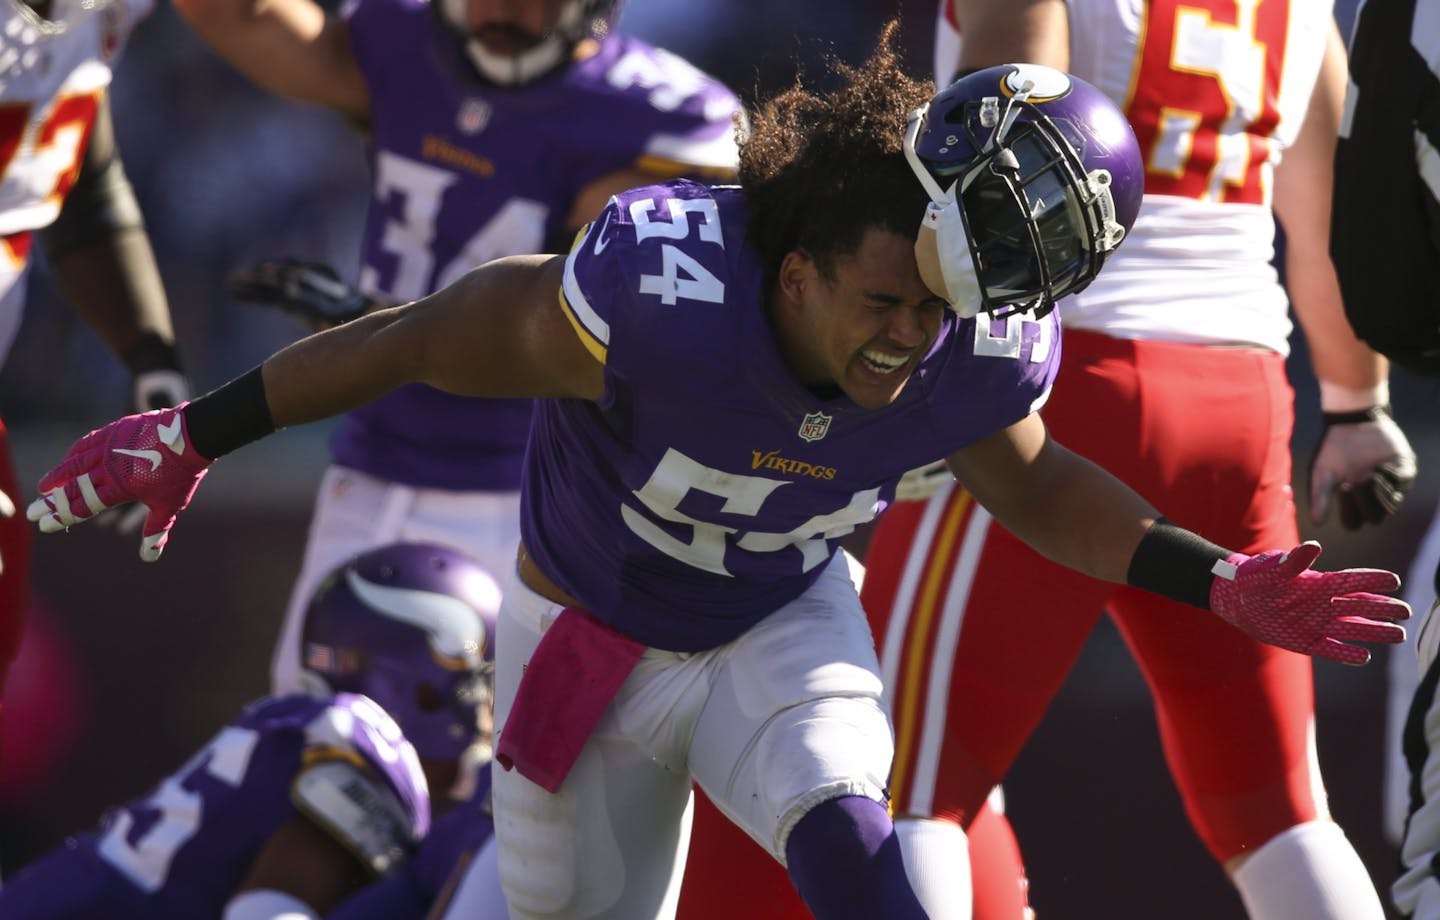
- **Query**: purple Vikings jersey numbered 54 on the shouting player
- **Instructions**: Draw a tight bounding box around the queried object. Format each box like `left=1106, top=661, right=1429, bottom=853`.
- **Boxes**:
left=521, top=181, right=1060, bottom=651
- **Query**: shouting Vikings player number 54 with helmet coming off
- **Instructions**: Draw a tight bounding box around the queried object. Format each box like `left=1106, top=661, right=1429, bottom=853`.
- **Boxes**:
left=27, top=23, right=1410, bottom=919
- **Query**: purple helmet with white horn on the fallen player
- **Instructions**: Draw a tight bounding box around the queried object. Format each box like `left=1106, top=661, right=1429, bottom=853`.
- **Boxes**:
left=301, top=543, right=500, bottom=760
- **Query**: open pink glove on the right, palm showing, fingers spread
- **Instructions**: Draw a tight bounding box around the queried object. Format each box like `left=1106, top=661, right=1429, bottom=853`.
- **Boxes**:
left=1210, top=540, right=1410, bottom=665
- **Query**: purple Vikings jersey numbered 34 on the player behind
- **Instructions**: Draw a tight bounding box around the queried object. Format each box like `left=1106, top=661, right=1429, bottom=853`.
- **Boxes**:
left=331, top=0, right=739, bottom=491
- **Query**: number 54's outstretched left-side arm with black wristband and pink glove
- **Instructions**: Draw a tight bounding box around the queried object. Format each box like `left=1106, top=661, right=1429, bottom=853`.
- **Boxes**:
left=27, top=256, right=605, bottom=562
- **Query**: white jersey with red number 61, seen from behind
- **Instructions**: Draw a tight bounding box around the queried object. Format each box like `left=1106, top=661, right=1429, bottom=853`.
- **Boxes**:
left=1061, top=0, right=1332, bottom=354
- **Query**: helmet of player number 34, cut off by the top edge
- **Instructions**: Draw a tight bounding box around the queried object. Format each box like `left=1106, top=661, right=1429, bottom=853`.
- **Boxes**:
left=431, top=0, right=621, bottom=86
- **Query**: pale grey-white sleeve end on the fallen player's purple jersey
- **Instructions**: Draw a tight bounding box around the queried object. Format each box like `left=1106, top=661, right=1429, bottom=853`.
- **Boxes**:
left=291, top=759, right=416, bottom=875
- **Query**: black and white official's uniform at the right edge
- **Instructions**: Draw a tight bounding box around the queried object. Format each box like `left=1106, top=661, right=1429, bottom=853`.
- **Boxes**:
left=1331, top=0, right=1440, bottom=920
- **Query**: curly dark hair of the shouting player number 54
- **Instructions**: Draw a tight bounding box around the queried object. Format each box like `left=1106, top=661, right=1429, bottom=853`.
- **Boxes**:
left=740, top=19, right=935, bottom=278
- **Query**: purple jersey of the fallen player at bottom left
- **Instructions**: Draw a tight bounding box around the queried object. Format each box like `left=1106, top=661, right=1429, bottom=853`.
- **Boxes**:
left=0, top=694, right=431, bottom=920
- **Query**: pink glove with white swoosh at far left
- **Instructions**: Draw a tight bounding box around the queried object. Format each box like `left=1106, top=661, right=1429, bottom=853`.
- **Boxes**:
left=26, top=403, right=213, bottom=562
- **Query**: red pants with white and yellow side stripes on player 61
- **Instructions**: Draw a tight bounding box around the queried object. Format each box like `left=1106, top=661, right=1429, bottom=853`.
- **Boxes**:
left=863, top=331, right=1325, bottom=862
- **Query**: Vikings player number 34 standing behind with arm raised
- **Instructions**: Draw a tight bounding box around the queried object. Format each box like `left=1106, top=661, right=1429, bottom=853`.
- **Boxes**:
left=176, top=0, right=739, bottom=705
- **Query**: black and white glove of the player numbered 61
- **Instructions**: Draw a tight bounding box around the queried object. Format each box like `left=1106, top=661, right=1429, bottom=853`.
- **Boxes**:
left=1309, top=406, right=1416, bottom=530
